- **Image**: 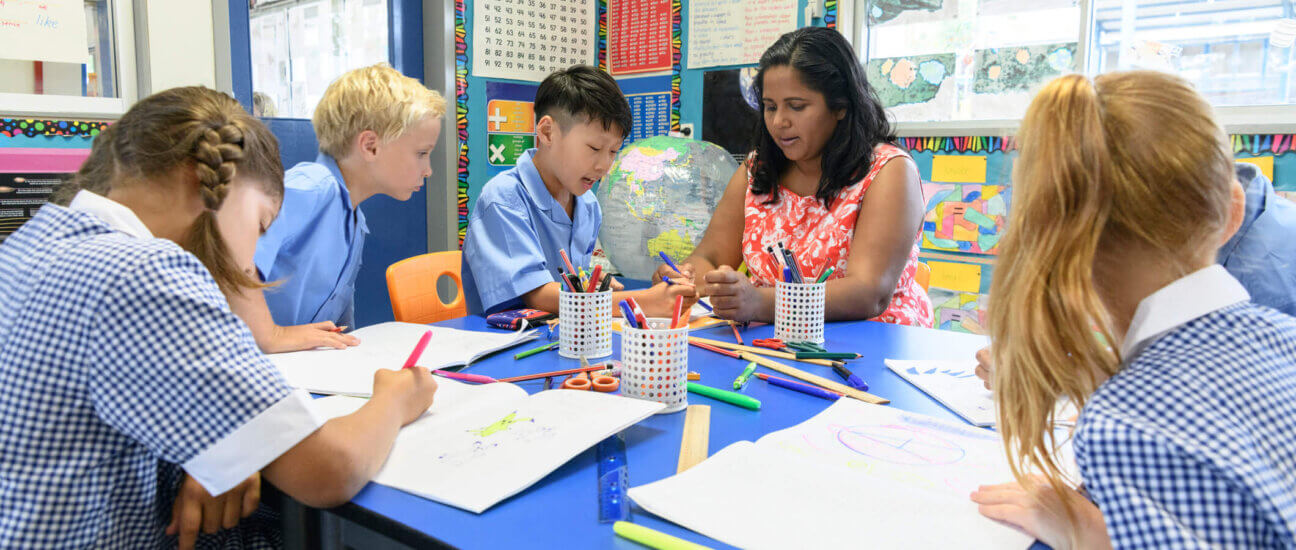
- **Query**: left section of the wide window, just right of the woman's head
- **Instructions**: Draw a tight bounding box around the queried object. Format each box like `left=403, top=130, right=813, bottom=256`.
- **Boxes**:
left=857, top=0, right=1081, bottom=121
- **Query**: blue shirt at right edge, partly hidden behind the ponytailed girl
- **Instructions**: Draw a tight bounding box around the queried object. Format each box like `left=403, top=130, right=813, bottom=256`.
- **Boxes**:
left=1216, top=162, right=1296, bottom=315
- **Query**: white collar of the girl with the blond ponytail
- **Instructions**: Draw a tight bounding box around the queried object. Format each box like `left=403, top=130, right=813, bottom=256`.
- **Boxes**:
left=1121, top=265, right=1251, bottom=361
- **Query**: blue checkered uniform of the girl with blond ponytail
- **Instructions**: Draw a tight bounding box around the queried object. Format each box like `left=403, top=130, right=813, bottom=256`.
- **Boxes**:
left=1076, top=302, right=1296, bottom=549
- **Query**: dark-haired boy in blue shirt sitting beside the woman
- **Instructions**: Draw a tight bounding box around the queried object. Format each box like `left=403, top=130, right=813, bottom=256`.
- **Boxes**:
left=461, top=65, right=695, bottom=317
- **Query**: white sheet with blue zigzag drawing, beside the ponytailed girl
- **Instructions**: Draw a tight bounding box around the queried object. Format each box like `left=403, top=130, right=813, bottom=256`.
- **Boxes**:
left=885, top=359, right=995, bottom=425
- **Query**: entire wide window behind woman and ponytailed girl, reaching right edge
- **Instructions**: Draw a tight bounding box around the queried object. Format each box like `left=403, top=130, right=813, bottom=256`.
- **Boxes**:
left=854, top=0, right=1296, bottom=126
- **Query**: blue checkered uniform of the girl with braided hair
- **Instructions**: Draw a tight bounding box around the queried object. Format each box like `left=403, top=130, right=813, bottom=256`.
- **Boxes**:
left=0, top=205, right=290, bottom=549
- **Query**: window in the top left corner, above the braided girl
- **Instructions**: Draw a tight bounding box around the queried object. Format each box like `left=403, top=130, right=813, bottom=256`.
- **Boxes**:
left=0, top=0, right=135, bottom=117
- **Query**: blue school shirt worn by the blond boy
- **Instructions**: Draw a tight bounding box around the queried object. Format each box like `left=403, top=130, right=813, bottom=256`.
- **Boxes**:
left=255, top=153, right=369, bottom=327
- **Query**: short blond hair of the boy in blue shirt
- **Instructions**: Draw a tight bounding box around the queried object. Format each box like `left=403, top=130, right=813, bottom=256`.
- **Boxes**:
left=311, top=64, right=446, bottom=158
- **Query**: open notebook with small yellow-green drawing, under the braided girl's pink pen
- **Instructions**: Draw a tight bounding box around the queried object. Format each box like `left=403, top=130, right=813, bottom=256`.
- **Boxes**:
left=312, top=377, right=665, bottom=514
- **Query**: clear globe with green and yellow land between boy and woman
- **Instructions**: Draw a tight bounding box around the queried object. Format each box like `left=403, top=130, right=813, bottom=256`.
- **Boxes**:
left=596, top=136, right=737, bottom=279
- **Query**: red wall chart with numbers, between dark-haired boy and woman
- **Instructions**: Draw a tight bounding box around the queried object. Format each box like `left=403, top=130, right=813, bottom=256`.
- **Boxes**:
left=608, top=0, right=671, bottom=74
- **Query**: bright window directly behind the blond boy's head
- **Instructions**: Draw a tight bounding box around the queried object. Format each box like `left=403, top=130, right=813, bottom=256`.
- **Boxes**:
left=249, top=0, right=388, bottom=118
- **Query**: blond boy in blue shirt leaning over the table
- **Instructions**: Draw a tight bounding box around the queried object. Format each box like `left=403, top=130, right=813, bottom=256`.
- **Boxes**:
left=229, top=64, right=446, bottom=353
